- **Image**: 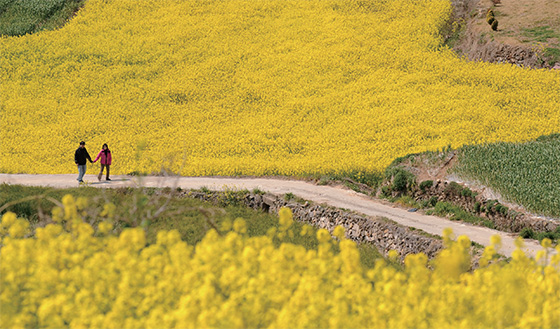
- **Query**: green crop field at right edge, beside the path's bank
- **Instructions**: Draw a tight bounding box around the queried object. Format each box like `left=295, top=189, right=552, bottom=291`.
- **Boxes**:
left=453, top=133, right=560, bottom=217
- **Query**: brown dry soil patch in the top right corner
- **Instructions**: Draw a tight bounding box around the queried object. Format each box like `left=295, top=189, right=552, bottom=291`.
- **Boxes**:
left=450, top=0, right=560, bottom=68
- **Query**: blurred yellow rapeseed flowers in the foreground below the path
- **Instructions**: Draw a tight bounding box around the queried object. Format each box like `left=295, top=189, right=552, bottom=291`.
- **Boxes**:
left=0, top=195, right=560, bottom=328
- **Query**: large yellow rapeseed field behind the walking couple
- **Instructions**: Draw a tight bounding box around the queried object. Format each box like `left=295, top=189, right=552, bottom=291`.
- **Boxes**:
left=0, top=0, right=560, bottom=175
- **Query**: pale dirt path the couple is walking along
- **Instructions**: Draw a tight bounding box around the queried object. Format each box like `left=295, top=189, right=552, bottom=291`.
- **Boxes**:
left=0, top=174, right=541, bottom=256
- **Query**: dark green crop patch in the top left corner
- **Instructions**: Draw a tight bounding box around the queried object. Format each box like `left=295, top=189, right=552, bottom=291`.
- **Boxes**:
left=0, top=0, right=84, bottom=36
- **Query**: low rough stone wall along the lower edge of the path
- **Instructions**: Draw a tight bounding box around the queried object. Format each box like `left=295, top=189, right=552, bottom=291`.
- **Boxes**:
left=185, top=192, right=443, bottom=259
